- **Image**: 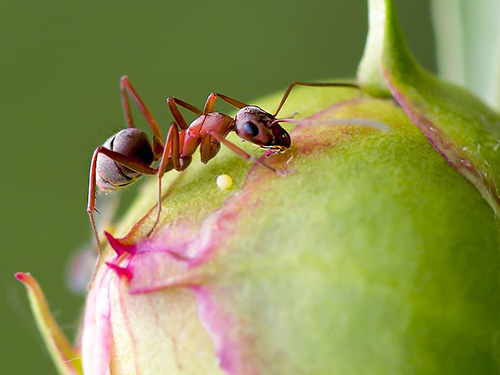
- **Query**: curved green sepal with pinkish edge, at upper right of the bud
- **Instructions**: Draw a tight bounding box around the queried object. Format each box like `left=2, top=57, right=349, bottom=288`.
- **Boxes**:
left=358, top=0, right=500, bottom=216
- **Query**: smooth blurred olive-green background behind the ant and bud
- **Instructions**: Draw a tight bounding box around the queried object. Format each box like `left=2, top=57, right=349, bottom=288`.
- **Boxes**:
left=0, top=0, right=435, bottom=375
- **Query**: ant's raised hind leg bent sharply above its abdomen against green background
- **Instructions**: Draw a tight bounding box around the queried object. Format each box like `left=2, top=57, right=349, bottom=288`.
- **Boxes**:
left=120, top=76, right=163, bottom=157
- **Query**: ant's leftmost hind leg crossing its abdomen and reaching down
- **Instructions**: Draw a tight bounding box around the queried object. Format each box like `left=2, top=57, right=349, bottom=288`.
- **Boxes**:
left=87, top=146, right=157, bottom=254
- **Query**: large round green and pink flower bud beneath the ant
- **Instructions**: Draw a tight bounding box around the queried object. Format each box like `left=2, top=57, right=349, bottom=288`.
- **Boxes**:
left=15, top=0, right=500, bottom=375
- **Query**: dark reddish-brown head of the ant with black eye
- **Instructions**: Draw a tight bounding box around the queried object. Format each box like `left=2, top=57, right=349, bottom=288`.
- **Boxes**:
left=234, top=106, right=291, bottom=150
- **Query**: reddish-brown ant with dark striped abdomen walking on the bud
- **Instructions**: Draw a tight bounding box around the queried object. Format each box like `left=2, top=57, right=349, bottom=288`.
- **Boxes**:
left=87, top=76, right=359, bottom=252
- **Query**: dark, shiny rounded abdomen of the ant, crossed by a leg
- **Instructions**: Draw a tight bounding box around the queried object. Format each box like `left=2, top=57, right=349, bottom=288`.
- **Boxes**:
left=96, top=128, right=154, bottom=191
